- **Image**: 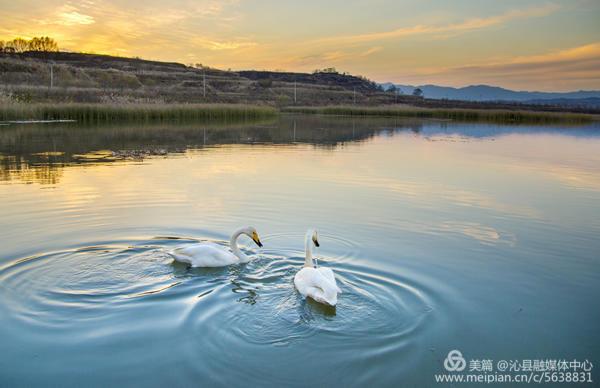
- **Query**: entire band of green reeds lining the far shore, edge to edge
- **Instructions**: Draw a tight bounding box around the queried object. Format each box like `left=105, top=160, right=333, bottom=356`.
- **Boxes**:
left=0, top=103, right=600, bottom=124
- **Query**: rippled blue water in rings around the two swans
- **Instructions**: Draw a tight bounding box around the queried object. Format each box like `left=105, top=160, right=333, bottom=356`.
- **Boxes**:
left=0, top=234, right=435, bottom=384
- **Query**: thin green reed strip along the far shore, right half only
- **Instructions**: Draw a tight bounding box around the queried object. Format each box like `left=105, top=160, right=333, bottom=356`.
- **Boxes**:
left=284, top=106, right=598, bottom=124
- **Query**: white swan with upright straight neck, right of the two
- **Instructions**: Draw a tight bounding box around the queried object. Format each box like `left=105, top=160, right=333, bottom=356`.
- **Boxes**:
left=294, top=229, right=342, bottom=306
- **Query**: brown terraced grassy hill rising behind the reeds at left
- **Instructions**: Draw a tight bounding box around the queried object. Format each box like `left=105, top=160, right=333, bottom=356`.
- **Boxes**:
left=0, top=52, right=386, bottom=105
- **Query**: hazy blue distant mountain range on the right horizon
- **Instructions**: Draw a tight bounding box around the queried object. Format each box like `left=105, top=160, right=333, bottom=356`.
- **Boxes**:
left=381, top=82, right=600, bottom=107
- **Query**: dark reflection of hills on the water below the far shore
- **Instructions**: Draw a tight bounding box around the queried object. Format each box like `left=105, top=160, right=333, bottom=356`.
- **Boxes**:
left=0, top=115, right=599, bottom=184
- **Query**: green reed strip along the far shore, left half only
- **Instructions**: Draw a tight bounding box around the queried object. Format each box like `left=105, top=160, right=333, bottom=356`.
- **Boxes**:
left=0, top=103, right=277, bottom=123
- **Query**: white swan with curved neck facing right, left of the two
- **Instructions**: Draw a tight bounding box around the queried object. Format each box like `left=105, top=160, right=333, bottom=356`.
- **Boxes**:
left=167, top=226, right=262, bottom=267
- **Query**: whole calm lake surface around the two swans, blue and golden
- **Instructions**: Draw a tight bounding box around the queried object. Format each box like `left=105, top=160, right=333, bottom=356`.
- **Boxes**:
left=0, top=116, right=600, bottom=387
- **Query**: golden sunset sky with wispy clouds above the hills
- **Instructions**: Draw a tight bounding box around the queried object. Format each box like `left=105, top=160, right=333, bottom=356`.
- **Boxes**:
left=0, top=0, right=600, bottom=91
